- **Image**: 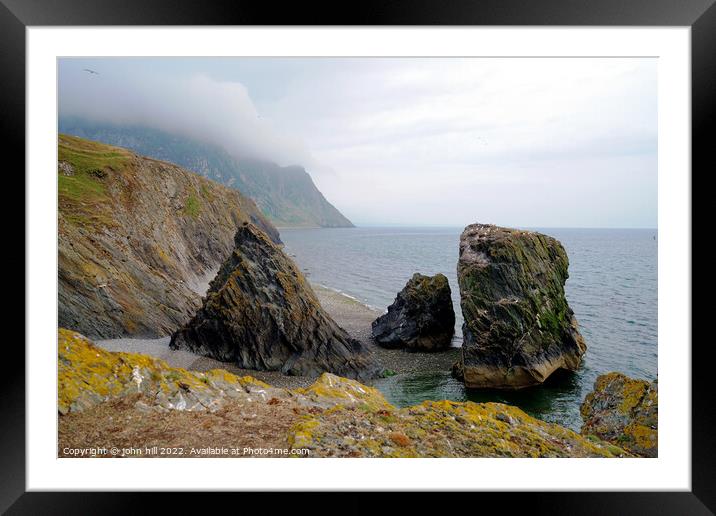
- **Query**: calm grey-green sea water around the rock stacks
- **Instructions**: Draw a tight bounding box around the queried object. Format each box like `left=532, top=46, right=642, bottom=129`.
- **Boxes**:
left=281, top=228, right=657, bottom=429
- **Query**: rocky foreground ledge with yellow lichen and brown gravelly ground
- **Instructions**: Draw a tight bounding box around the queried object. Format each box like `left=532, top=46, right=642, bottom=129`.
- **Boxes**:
left=58, top=329, right=630, bottom=457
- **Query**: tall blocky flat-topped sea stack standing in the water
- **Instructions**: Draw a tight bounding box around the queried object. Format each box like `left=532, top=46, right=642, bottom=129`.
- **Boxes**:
left=454, top=224, right=587, bottom=389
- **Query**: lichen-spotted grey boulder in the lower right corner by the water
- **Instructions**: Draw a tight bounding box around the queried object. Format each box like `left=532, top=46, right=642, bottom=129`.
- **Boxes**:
left=580, top=373, right=659, bottom=457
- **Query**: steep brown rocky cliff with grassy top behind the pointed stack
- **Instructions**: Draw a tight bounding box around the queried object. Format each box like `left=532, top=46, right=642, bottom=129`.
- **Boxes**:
left=57, top=134, right=279, bottom=338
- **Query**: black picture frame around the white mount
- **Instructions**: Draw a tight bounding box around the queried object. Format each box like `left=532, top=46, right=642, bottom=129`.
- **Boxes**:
left=5, top=0, right=716, bottom=514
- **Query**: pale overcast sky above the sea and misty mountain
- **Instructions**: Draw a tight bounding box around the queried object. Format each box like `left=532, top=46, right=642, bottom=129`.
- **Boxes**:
left=58, top=58, right=657, bottom=228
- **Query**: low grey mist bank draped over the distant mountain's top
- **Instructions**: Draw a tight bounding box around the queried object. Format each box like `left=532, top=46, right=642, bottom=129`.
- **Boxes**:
left=58, top=59, right=313, bottom=166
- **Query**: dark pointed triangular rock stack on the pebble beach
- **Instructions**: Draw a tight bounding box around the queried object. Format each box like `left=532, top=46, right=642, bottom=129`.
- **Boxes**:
left=170, top=224, right=378, bottom=379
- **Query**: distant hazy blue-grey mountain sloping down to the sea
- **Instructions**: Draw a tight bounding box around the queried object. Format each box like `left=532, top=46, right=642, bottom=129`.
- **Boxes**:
left=59, top=118, right=353, bottom=227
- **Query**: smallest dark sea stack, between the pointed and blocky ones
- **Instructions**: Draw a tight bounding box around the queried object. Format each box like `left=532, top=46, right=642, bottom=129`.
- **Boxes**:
left=372, top=273, right=455, bottom=351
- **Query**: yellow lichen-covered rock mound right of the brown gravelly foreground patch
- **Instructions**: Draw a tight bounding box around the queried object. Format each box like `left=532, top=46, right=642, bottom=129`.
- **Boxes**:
left=289, top=401, right=629, bottom=457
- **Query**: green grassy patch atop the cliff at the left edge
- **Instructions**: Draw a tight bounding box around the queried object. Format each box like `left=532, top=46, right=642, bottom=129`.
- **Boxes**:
left=57, top=134, right=131, bottom=225
